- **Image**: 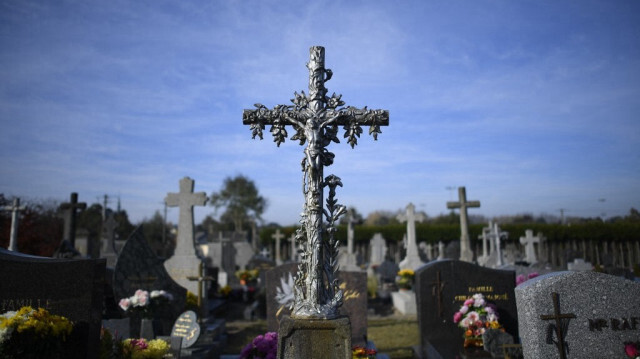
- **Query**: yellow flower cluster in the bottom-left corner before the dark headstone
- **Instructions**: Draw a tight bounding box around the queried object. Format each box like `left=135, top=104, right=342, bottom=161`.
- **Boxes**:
left=0, top=307, right=73, bottom=359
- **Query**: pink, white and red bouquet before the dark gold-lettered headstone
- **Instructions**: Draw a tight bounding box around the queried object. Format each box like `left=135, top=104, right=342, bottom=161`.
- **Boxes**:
left=453, top=293, right=502, bottom=348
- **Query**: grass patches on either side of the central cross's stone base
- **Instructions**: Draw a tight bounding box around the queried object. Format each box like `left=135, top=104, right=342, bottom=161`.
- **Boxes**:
left=223, top=318, right=420, bottom=359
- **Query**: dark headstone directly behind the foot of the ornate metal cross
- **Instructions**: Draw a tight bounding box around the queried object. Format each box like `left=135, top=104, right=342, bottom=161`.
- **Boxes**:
left=266, top=263, right=367, bottom=345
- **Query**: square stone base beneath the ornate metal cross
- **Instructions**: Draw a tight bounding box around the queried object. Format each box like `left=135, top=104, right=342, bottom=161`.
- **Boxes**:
left=278, top=317, right=352, bottom=359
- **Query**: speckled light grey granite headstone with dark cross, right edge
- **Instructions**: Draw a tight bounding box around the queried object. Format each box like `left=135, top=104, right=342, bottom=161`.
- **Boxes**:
left=515, top=271, right=640, bottom=358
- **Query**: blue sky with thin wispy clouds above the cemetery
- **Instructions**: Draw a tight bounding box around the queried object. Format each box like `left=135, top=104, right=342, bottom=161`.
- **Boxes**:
left=0, top=0, right=640, bottom=225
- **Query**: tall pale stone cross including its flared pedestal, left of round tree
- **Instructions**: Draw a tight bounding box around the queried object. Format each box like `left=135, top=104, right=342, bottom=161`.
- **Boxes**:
left=164, top=177, right=207, bottom=293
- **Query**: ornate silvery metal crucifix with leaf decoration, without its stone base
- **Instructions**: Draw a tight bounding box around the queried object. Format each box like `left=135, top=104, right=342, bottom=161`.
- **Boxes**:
left=242, top=46, right=389, bottom=319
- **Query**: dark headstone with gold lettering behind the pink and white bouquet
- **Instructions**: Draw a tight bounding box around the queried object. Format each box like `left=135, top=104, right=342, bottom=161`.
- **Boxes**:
left=415, top=260, right=518, bottom=359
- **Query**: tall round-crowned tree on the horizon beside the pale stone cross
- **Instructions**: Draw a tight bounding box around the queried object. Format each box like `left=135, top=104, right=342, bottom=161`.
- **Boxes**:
left=210, top=175, right=267, bottom=231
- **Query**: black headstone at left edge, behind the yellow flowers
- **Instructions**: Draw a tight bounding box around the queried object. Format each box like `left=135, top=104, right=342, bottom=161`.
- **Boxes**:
left=0, top=248, right=106, bottom=359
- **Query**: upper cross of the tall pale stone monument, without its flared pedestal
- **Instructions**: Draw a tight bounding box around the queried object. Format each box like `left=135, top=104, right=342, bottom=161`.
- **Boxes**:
left=164, top=177, right=207, bottom=255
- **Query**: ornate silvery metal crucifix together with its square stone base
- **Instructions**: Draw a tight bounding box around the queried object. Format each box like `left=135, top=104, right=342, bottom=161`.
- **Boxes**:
left=243, top=46, right=389, bottom=358
